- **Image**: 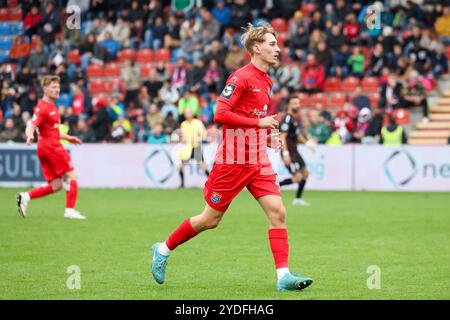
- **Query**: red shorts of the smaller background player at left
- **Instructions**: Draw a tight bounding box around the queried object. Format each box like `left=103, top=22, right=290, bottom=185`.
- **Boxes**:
left=37, top=145, right=73, bottom=182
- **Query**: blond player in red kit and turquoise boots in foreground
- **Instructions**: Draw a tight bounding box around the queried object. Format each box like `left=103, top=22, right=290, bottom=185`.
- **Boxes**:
left=151, top=24, right=312, bottom=290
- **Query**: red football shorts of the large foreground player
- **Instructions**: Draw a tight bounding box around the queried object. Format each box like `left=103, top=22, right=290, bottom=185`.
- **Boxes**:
left=203, top=164, right=281, bottom=212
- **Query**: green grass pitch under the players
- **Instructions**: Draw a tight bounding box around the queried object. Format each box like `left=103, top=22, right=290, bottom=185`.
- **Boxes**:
left=0, top=189, right=450, bottom=300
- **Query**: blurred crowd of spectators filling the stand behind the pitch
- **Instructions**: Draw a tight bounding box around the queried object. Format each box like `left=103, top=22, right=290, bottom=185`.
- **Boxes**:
left=0, top=0, right=450, bottom=144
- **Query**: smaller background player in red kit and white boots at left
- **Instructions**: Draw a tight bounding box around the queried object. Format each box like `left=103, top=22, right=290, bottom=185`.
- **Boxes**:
left=17, top=76, right=86, bottom=219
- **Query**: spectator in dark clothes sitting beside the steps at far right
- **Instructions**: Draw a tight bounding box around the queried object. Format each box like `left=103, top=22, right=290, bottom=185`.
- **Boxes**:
left=402, top=70, right=428, bottom=122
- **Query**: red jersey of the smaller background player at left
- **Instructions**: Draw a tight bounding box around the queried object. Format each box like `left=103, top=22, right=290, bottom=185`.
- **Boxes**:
left=31, top=100, right=61, bottom=145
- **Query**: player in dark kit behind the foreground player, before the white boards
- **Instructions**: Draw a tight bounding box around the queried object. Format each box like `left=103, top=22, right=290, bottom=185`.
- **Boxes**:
left=280, top=95, right=311, bottom=206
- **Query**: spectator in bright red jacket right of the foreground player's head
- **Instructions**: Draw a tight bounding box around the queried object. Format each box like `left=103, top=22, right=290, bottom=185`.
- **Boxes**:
left=301, top=53, right=325, bottom=93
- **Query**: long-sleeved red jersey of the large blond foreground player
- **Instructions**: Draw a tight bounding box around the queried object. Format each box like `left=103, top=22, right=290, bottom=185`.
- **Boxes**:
left=215, top=63, right=272, bottom=165
